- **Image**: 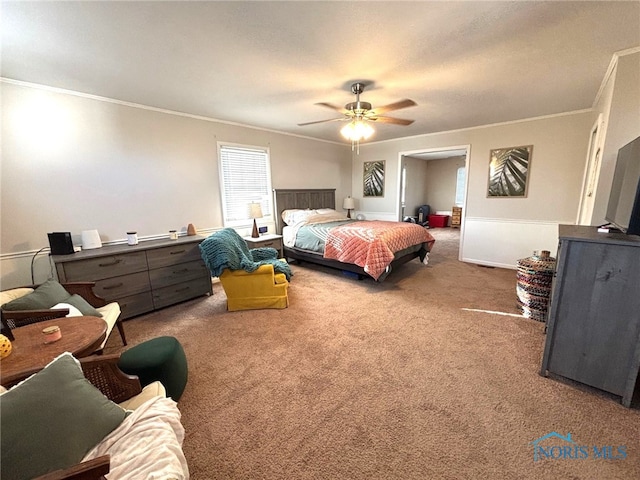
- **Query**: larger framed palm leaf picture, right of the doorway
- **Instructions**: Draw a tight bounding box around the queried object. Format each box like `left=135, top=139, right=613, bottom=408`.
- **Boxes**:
left=487, top=145, right=533, bottom=197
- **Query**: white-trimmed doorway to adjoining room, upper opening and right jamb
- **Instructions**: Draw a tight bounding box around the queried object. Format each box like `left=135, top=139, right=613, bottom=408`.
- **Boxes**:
left=396, top=145, right=470, bottom=258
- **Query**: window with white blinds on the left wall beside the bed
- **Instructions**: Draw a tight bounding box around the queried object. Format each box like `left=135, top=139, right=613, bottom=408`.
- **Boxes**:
left=218, top=144, right=273, bottom=227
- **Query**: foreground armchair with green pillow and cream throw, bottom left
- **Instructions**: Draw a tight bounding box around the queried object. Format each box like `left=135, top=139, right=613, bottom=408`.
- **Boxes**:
left=0, top=352, right=189, bottom=480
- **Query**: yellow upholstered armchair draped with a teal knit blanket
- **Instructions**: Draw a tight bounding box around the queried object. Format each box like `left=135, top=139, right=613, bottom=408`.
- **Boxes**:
left=200, top=228, right=291, bottom=311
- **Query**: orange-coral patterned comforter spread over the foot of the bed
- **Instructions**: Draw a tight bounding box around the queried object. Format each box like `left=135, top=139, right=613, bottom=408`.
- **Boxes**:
left=324, top=220, right=435, bottom=280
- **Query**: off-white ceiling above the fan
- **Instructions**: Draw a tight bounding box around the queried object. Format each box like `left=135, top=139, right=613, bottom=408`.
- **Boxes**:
left=0, top=1, right=640, bottom=141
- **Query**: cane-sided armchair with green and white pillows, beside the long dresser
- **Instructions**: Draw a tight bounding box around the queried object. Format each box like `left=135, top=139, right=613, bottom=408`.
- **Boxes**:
left=0, top=280, right=127, bottom=351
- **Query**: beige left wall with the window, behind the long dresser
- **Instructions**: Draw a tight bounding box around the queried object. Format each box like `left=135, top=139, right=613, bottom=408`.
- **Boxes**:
left=0, top=82, right=351, bottom=288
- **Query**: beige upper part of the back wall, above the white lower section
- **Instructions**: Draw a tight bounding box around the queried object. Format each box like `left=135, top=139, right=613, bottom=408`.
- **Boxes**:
left=352, top=111, right=592, bottom=223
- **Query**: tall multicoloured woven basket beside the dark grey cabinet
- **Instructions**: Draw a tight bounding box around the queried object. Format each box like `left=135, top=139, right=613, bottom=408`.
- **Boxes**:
left=516, top=250, right=556, bottom=322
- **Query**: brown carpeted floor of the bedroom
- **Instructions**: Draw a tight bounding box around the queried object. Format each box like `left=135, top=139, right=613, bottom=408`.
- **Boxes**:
left=106, top=229, right=640, bottom=480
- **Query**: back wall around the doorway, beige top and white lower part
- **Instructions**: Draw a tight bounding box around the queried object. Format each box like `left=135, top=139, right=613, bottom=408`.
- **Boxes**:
left=352, top=110, right=593, bottom=267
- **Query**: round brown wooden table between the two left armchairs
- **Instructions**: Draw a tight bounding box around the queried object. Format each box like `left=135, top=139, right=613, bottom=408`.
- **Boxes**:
left=0, top=317, right=107, bottom=388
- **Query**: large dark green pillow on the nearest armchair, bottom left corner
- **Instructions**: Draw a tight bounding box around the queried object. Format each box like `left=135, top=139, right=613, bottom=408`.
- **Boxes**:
left=0, top=352, right=126, bottom=480
